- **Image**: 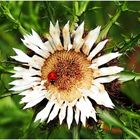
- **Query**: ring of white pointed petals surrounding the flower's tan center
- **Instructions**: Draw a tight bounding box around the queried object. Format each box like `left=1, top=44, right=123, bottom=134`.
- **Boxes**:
left=9, top=21, right=123, bottom=128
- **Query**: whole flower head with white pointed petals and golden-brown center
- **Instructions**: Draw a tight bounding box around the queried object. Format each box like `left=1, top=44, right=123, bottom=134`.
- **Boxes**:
left=10, top=22, right=123, bottom=128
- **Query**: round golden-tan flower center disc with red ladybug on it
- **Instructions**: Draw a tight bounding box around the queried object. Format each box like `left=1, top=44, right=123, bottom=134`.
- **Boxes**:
left=41, top=50, right=93, bottom=101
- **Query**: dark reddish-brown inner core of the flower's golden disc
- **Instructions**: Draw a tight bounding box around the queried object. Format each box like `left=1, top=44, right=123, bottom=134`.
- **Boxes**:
left=55, top=59, right=82, bottom=90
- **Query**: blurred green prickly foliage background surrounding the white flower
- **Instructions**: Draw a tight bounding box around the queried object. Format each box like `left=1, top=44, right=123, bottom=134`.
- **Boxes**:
left=0, top=1, right=140, bottom=139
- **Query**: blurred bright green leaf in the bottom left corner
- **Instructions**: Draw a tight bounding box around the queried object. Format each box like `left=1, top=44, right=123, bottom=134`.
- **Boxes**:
left=0, top=97, right=32, bottom=139
